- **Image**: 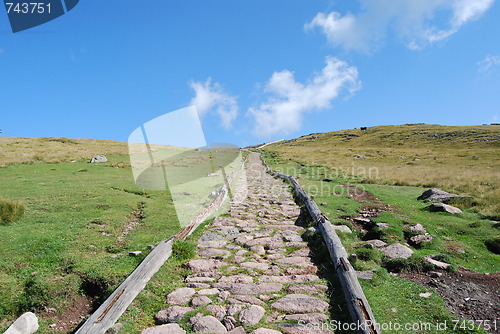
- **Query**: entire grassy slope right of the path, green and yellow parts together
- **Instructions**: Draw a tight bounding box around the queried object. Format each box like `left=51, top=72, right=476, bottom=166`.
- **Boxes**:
left=265, top=125, right=500, bottom=333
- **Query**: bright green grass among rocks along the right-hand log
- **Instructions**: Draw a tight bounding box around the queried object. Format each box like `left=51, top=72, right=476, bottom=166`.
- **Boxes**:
left=263, top=148, right=500, bottom=334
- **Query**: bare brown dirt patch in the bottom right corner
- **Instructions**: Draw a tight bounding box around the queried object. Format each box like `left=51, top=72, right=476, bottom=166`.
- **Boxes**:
left=398, top=268, right=500, bottom=334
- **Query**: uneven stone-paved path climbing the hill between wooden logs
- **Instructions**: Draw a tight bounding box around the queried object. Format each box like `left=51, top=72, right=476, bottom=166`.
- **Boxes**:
left=142, top=153, right=332, bottom=334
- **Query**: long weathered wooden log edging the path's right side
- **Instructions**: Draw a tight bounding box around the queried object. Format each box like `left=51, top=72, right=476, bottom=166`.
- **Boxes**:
left=262, top=160, right=381, bottom=334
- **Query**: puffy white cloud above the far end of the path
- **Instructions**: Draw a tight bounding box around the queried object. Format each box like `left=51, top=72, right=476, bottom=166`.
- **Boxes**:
left=248, top=57, right=361, bottom=137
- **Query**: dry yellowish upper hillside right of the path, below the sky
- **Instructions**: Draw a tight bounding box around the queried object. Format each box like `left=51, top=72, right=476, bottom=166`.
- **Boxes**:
left=265, top=124, right=500, bottom=219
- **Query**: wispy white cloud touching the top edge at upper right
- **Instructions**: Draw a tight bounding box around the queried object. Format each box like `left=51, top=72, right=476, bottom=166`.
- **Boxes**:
left=305, top=0, right=495, bottom=52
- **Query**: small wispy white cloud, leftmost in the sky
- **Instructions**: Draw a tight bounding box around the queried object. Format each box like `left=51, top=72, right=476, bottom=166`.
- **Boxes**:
left=190, top=78, right=238, bottom=129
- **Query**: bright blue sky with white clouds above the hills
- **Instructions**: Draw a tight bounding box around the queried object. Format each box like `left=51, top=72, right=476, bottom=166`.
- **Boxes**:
left=0, top=0, right=500, bottom=146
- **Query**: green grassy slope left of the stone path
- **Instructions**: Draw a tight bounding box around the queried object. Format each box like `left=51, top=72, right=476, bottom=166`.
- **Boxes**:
left=0, top=138, right=179, bottom=333
